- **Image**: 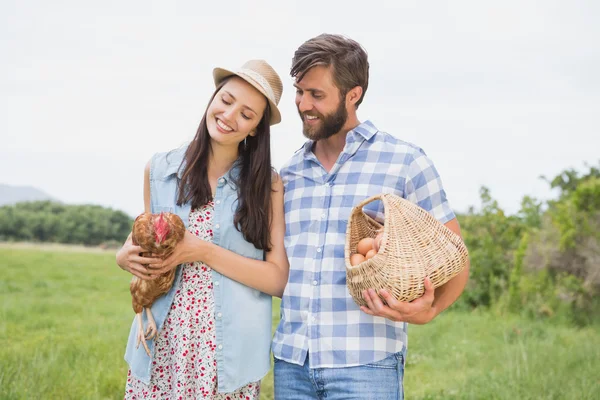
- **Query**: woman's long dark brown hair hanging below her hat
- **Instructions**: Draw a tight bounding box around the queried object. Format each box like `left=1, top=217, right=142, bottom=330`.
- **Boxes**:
left=177, top=79, right=273, bottom=251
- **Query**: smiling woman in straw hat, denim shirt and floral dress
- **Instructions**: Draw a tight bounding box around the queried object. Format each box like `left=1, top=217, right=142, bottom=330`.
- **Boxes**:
left=117, top=60, right=289, bottom=399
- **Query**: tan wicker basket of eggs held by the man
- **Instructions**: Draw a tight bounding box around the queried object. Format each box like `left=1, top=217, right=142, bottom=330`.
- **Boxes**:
left=345, top=194, right=469, bottom=306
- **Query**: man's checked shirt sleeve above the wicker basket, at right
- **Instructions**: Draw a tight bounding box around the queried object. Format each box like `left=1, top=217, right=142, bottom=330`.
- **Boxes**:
left=404, top=150, right=456, bottom=224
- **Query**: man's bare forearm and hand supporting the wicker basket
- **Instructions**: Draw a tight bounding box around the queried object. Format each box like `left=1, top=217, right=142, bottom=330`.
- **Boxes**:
left=360, top=218, right=470, bottom=325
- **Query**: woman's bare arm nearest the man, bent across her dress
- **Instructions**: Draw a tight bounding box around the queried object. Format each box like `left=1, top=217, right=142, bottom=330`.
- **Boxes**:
left=150, top=175, right=289, bottom=297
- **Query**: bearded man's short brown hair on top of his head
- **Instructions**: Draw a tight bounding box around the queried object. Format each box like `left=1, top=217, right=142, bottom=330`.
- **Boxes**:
left=290, top=33, right=369, bottom=108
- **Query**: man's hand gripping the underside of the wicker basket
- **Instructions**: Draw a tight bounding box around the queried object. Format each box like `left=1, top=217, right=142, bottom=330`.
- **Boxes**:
left=360, top=278, right=437, bottom=325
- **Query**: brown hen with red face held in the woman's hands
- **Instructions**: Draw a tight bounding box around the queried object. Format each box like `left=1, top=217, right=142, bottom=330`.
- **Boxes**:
left=129, top=213, right=185, bottom=355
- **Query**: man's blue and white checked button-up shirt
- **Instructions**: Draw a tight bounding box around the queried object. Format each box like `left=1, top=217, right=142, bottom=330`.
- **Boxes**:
left=273, top=121, right=455, bottom=368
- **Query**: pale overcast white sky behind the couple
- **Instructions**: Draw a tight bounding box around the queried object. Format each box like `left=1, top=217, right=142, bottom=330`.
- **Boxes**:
left=0, top=0, right=600, bottom=216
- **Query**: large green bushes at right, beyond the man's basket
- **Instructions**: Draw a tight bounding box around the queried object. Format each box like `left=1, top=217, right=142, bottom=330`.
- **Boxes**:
left=457, top=162, right=600, bottom=325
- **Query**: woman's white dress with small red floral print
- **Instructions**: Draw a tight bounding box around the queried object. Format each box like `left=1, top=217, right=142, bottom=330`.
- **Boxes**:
left=125, top=202, right=260, bottom=400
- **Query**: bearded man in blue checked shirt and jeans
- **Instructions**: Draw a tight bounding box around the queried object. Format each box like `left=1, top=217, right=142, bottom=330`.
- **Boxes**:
left=273, top=34, right=468, bottom=400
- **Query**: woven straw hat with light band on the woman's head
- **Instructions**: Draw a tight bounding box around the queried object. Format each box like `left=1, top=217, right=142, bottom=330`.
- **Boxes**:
left=213, top=60, right=283, bottom=125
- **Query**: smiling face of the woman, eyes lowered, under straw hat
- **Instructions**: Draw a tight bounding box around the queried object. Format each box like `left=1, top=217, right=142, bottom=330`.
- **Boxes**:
left=206, top=76, right=267, bottom=147
